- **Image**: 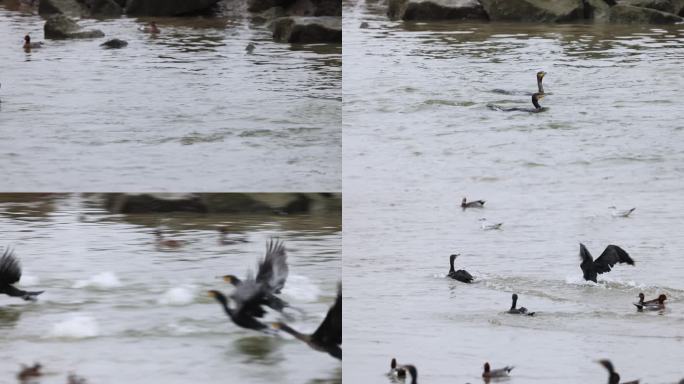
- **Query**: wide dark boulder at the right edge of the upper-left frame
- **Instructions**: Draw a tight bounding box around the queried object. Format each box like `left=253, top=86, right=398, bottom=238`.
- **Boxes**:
left=272, top=16, right=342, bottom=44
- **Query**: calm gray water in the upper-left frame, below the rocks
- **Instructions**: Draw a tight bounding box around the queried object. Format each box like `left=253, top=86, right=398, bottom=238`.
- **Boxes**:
left=0, top=1, right=342, bottom=192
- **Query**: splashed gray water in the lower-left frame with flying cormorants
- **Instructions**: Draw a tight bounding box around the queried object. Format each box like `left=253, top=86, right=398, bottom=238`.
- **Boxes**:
left=0, top=195, right=341, bottom=384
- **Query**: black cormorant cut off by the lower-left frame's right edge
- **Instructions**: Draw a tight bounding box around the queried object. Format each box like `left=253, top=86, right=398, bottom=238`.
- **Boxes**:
left=272, top=285, right=342, bottom=360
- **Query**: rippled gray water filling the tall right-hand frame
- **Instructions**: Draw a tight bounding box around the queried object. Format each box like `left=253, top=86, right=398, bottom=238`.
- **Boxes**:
left=343, top=2, right=684, bottom=384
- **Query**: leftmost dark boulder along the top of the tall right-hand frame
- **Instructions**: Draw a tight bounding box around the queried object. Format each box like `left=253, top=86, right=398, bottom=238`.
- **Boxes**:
left=388, top=0, right=488, bottom=20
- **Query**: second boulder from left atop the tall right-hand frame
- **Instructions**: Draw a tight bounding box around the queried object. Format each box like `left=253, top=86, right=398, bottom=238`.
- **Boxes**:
left=480, top=0, right=584, bottom=22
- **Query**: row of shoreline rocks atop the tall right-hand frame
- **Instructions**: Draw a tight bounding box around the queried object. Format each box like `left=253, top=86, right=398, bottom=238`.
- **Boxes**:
left=387, top=0, right=684, bottom=24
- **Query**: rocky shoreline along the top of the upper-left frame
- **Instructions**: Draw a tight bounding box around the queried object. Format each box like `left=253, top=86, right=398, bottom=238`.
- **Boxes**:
left=22, top=0, right=342, bottom=44
